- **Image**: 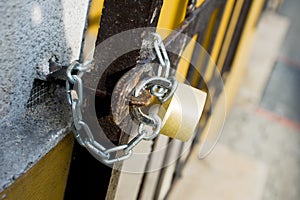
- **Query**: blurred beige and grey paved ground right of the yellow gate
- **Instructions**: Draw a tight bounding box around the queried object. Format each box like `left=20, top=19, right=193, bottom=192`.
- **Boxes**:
left=169, top=0, right=300, bottom=200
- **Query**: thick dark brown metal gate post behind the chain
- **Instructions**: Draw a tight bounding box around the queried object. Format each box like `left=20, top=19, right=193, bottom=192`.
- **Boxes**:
left=65, top=0, right=162, bottom=199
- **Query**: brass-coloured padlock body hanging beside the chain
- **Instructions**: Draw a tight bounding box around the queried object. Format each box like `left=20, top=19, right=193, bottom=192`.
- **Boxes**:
left=158, top=83, right=207, bottom=142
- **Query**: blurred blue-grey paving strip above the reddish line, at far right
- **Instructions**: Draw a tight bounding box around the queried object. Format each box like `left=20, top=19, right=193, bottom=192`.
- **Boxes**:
left=260, top=0, right=300, bottom=123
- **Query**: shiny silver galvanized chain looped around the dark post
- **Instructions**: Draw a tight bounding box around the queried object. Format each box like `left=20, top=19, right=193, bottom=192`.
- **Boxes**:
left=66, top=33, right=177, bottom=164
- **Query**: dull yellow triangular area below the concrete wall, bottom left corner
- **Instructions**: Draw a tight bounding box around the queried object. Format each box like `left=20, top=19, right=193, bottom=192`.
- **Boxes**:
left=0, top=134, right=74, bottom=200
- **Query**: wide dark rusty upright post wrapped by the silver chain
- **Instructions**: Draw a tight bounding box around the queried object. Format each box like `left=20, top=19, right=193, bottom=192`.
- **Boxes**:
left=65, top=0, right=162, bottom=199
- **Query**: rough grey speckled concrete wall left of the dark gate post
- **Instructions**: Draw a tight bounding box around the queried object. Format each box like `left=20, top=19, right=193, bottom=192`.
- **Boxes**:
left=0, top=0, right=89, bottom=191
